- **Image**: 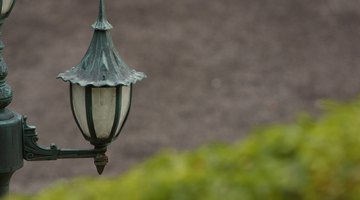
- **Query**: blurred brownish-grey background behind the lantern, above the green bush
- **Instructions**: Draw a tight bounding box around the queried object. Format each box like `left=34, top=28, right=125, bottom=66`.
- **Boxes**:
left=3, top=0, right=360, bottom=192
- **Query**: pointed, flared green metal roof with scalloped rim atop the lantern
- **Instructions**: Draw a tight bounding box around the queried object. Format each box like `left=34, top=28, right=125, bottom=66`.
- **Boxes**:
left=57, top=0, right=146, bottom=87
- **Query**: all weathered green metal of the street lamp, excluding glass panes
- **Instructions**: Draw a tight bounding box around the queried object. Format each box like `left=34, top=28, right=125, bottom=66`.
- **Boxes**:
left=0, top=0, right=146, bottom=198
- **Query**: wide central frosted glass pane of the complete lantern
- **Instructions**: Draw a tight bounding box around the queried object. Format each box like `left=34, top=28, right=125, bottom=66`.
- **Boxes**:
left=92, top=88, right=116, bottom=139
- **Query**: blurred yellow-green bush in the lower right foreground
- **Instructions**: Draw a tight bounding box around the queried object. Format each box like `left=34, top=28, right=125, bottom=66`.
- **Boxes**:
left=8, top=99, right=360, bottom=200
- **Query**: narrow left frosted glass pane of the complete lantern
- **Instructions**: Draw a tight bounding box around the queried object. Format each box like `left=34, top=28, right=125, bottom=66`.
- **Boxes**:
left=71, top=84, right=90, bottom=137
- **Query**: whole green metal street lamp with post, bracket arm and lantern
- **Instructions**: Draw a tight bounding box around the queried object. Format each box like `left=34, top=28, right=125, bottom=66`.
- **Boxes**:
left=0, top=0, right=146, bottom=196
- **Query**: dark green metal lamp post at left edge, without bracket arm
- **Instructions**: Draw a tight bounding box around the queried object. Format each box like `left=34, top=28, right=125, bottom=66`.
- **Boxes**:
left=0, top=0, right=19, bottom=197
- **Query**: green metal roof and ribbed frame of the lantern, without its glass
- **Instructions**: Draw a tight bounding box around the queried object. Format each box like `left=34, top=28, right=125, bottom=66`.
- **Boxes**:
left=58, top=0, right=146, bottom=173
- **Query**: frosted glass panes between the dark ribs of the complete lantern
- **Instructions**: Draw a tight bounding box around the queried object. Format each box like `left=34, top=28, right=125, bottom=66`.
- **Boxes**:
left=71, top=84, right=131, bottom=139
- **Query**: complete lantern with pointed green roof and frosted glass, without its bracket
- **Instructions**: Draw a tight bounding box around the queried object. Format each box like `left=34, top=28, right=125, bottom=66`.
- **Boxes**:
left=58, top=0, right=146, bottom=148
